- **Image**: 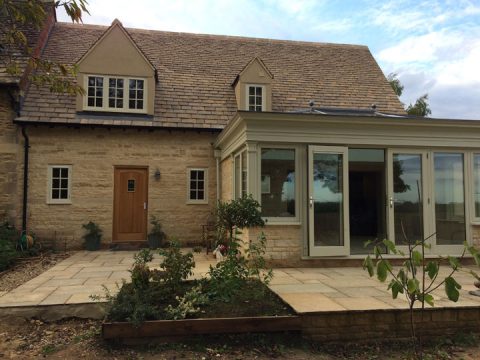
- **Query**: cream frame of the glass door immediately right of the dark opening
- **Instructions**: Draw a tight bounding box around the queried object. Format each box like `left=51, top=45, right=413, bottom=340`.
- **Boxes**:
left=387, top=148, right=435, bottom=254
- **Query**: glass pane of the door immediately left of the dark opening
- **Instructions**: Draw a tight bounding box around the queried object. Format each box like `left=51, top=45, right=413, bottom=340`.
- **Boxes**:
left=312, top=153, right=344, bottom=246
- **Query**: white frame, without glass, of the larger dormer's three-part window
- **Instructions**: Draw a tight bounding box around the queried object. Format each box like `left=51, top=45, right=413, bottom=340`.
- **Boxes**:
left=83, top=74, right=148, bottom=114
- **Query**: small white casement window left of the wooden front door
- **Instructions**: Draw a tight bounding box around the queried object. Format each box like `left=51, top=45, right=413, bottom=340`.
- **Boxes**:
left=47, top=165, right=72, bottom=204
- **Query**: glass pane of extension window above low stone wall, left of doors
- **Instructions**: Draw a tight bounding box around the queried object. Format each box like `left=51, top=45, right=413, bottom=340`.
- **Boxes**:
left=261, top=149, right=295, bottom=217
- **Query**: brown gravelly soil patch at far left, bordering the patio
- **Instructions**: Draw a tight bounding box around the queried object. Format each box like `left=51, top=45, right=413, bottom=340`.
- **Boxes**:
left=0, top=252, right=70, bottom=292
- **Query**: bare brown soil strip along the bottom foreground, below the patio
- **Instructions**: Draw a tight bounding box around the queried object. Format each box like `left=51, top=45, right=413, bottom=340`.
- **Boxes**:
left=0, top=318, right=480, bottom=360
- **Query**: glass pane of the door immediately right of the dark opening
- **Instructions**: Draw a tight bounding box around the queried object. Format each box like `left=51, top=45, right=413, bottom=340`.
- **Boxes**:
left=392, top=154, right=424, bottom=245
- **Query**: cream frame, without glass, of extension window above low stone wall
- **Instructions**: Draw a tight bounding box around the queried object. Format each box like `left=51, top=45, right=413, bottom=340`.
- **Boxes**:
left=257, top=143, right=298, bottom=225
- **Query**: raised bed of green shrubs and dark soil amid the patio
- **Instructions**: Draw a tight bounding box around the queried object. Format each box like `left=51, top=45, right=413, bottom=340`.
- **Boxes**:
left=96, top=197, right=293, bottom=325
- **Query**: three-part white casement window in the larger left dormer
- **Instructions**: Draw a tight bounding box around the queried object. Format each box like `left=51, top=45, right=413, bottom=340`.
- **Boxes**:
left=84, top=75, right=147, bottom=113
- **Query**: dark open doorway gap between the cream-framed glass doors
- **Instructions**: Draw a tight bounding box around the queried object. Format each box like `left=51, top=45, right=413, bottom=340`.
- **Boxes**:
left=348, top=149, right=387, bottom=254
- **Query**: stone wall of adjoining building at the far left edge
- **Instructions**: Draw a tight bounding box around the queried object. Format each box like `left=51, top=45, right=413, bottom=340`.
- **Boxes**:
left=0, top=88, right=21, bottom=222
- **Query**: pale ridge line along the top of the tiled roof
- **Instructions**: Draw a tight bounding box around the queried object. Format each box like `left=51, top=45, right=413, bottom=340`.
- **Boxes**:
left=56, top=19, right=368, bottom=49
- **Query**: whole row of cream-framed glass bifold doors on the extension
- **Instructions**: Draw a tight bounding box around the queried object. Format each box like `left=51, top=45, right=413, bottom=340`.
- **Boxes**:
left=308, top=146, right=467, bottom=256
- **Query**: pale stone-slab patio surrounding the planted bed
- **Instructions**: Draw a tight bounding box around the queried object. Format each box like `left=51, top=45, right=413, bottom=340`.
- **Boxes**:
left=0, top=251, right=480, bottom=313
